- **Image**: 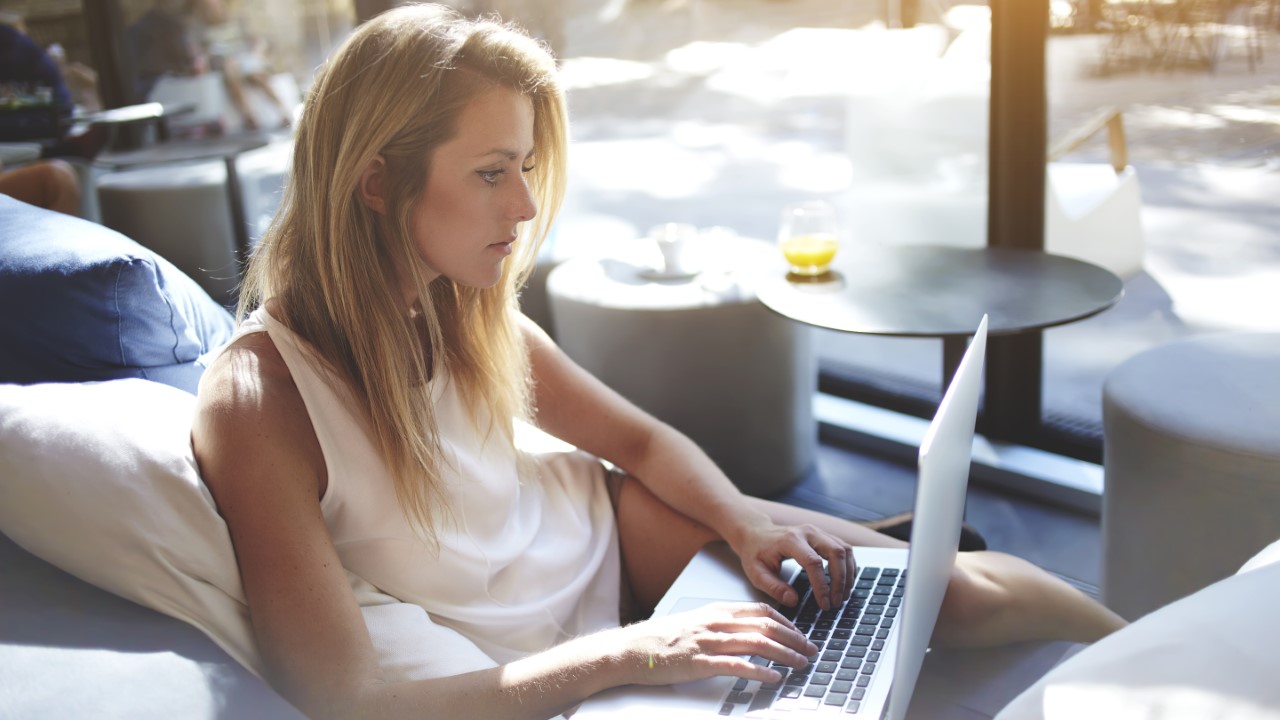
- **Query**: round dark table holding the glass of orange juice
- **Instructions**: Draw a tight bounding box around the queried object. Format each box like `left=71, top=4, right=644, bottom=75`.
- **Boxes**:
left=756, top=245, right=1124, bottom=397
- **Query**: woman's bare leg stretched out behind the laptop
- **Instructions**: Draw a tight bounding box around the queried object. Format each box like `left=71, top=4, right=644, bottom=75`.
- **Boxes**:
left=613, top=478, right=1125, bottom=647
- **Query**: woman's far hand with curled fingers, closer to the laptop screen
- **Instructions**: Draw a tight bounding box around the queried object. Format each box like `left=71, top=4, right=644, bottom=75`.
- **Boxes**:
left=731, top=520, right=856, bottom=610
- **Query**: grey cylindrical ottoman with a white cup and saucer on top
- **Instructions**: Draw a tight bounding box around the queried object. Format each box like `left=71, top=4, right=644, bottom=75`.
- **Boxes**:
left=547, top=238, right=818, bottom=497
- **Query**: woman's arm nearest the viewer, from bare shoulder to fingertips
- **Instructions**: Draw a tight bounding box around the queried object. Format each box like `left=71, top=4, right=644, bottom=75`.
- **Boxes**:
left=192, top=333, right=814, bottom=719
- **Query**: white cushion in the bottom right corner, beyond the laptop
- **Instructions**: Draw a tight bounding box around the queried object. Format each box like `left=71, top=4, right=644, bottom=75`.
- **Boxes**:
left=996, top=542, right=1280, bottom=720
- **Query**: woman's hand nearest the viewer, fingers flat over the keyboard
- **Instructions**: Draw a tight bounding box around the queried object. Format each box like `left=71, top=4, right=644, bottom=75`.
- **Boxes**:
left=618, top=602, right=818, bottom=685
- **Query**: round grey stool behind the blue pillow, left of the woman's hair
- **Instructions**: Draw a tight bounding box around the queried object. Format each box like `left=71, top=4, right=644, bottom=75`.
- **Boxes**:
left=97, top=160, right=239, bottom=304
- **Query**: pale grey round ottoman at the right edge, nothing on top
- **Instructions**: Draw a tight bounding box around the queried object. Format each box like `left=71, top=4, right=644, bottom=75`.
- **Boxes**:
left=1102, top=333, right=1280, bottom=619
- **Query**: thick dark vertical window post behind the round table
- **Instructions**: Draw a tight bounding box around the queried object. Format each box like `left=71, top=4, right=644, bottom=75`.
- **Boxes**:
left=983, top=0, right=1048, bottom=441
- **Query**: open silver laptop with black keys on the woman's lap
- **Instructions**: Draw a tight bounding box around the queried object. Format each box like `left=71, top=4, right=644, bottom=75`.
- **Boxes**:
left=573, top=315, right=987, bottom=720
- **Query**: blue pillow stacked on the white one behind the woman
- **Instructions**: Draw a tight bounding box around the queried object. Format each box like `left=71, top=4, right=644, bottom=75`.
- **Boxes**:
left=0, top=195, right=234, bottom=392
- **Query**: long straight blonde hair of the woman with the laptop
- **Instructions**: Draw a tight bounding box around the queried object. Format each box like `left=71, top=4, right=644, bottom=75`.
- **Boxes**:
left=237, top=5, right=567, bottom=542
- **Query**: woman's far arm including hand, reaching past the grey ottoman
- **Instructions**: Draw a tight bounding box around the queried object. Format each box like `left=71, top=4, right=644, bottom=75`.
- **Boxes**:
left=521, top=316, right=854, bottom=607
